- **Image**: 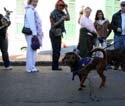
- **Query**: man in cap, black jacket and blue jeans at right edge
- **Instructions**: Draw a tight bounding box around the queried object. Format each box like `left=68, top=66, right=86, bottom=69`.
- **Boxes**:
left=111, top=0, right=125, bottom=69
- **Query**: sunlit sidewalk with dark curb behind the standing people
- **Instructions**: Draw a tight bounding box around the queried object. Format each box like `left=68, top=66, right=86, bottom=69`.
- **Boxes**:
left=0, top=46, right=75, bottom=66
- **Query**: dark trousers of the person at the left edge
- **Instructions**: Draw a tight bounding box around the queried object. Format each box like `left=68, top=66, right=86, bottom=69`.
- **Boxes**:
left=0, top=36, right=10, bottom=67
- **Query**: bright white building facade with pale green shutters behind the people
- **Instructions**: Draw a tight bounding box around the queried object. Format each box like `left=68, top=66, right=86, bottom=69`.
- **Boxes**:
left=0, top=0, right=119, bottom=54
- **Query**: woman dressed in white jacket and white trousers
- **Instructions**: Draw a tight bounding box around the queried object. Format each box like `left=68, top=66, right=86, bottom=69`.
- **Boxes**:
left=24, top=0, right=43, bottom=72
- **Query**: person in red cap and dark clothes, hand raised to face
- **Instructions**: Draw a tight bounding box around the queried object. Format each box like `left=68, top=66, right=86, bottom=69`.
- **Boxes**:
left=49, top=0, right=70, bottom=70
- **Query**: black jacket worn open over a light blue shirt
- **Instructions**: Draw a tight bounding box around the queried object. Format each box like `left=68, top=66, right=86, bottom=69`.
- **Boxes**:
left=111, top=10, right=122, bottom=35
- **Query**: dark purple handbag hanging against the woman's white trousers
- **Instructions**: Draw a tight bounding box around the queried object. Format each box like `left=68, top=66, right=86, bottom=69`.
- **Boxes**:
left=31, top=36, right=40, bottom=50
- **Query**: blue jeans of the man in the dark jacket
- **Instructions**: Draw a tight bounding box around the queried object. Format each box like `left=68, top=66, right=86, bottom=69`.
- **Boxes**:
left=114, top=35, right=125, bottom=49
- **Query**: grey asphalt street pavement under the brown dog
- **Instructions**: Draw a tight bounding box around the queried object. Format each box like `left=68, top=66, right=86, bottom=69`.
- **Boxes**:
left=0, top=65, right=125, bottom=106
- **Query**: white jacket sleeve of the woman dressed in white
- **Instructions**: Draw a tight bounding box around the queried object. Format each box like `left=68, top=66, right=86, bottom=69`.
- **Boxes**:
left=26, top=9, right=37, bottom=35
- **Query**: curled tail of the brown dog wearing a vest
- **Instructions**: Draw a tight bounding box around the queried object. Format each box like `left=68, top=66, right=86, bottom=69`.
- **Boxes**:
left=89, top=47, right=107, bottom=60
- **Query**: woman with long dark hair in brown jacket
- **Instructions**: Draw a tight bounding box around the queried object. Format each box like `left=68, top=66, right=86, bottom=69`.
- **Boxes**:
left=94, top=10, right=111, bottom=48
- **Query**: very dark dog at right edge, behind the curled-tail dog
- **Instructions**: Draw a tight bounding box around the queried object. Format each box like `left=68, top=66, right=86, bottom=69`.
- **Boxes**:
left=106, top=49, right=125, bottom=71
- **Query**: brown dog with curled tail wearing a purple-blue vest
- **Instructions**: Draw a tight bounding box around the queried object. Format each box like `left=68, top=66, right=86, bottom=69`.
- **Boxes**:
left=62, top=48, right=107, bottom=90
